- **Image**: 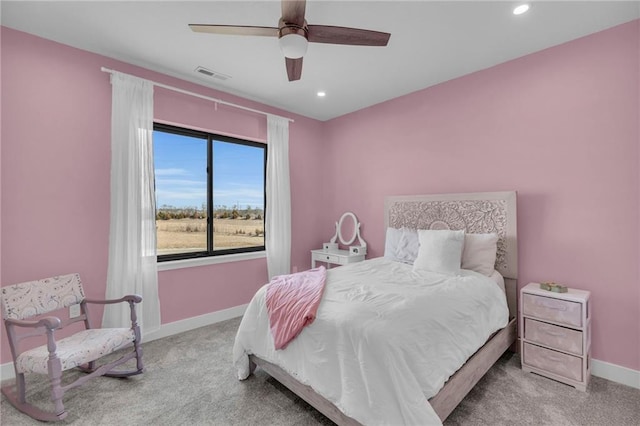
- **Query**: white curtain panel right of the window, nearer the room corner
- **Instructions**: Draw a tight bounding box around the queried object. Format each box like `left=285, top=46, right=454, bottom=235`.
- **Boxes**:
left=265, top=115, right=291, bottom=279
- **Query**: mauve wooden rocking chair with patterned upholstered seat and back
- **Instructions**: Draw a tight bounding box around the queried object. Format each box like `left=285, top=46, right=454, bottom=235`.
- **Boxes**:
left=1, top=274, right=143, bottom=421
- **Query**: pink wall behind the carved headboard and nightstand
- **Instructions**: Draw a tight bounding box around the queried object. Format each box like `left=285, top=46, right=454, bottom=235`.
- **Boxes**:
left=326, top=21, right=640, bottom=370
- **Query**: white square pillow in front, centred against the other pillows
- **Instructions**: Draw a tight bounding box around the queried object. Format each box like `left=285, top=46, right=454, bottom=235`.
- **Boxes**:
left=413, top=229, right=464, bottom=275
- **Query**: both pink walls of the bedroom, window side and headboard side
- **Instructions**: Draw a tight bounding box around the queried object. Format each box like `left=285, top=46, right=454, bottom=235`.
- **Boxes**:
left=0, top=22, right=640, bottom=370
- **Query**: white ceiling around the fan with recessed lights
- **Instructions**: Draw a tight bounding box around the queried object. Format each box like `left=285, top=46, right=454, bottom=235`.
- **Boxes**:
left=0, top=0, right=640, bottom=120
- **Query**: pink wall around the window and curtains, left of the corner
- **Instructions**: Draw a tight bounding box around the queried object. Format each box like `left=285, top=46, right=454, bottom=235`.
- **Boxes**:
left=0, top=28, right=324, bottom=363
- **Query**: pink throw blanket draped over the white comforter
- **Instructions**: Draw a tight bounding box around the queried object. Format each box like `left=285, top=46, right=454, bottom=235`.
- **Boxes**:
left=267, top=266, right=327, bottom=349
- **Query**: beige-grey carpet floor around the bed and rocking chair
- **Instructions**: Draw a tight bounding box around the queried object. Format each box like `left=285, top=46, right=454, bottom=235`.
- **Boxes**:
left=0, top=319, right=640, bottom=426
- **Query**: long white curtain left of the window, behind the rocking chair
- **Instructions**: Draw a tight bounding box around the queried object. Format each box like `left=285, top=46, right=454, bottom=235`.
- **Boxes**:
left=102, top=72, right=160, bottom=334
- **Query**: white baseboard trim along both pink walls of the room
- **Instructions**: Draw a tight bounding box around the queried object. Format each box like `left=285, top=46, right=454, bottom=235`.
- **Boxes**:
left=0, top=305, right=640, bottom=389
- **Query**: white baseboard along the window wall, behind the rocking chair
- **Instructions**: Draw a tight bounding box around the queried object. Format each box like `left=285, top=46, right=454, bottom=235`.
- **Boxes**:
left=0, top=304, right=249, bottom=381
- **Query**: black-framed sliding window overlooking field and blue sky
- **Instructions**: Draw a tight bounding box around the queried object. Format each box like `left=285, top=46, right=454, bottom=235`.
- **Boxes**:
left=153, top=123, right=267, bottom=262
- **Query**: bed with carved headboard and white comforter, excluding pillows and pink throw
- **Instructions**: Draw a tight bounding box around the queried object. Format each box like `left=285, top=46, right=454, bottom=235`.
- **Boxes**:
left=234, top=192, right=517, bottom=425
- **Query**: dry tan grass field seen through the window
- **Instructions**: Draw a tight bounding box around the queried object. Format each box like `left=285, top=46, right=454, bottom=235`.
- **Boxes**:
left=156, top=219, right=264, bottom=254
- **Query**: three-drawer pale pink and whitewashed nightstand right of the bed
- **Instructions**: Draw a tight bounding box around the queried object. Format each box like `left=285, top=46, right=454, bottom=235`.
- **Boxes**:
left=519, top=283, right=591, bottom=392
